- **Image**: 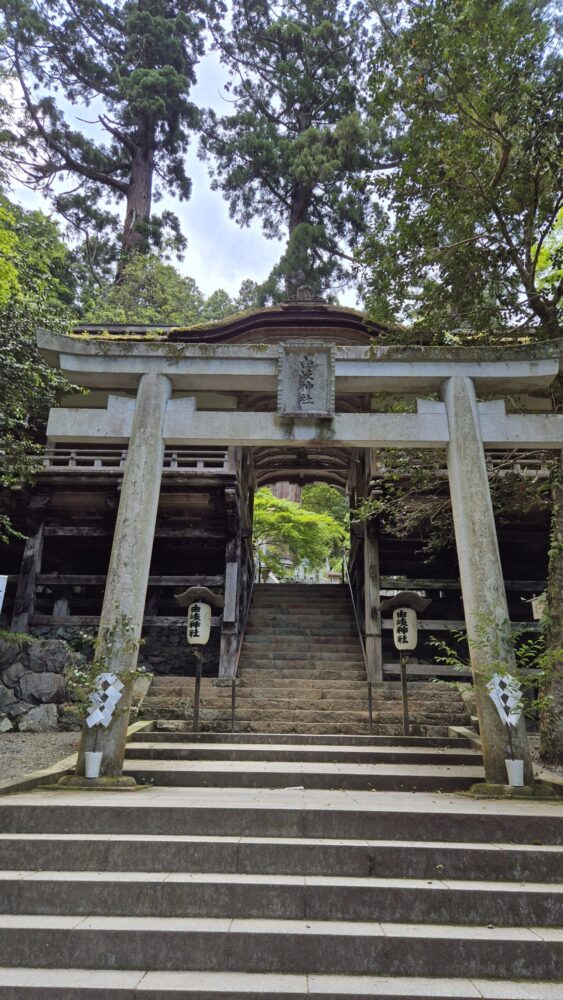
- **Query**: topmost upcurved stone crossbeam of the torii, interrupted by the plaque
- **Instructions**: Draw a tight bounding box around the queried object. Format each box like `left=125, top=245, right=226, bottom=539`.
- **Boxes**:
left=37, top=330, right=563, bottom=396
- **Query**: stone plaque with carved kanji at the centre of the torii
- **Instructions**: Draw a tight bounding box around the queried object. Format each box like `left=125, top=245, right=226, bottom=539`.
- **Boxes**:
left=278, top=341, right=334, bottom=417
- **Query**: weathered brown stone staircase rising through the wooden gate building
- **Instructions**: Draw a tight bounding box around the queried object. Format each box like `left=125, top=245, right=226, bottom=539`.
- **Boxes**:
left=143, top=584, right=469, bottom=736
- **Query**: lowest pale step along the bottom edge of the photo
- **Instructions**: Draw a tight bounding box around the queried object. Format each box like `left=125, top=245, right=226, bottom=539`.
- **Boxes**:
left=0, top=967, right=563, bottom=1000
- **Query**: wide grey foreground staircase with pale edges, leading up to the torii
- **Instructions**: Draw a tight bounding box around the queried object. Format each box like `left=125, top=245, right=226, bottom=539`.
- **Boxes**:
left=0, top=731, right=563, bottom=1000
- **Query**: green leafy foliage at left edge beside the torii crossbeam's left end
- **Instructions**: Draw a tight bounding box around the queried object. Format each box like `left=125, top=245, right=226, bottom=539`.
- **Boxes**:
left=0, top=197, right=73, bottom=541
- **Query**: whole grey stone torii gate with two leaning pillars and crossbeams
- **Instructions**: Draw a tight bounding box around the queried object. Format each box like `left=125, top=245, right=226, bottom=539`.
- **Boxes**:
left=38, top=331, right=563, bottom=783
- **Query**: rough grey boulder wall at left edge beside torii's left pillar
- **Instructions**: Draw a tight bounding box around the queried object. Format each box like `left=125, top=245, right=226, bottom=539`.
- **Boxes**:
left=0, top=632, right=83, bottom=732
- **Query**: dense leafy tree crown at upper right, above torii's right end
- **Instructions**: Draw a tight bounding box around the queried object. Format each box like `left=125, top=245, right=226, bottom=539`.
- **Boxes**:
left=362, top=0, right=563, bottom=338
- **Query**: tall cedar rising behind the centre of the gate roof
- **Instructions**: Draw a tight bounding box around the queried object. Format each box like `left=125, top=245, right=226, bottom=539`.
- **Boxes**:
left=202, top=0, right=392, bottom=300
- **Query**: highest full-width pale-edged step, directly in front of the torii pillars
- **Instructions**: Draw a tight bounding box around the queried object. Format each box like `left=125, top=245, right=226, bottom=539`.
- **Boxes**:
left=0, top=788, right=563, bottom=844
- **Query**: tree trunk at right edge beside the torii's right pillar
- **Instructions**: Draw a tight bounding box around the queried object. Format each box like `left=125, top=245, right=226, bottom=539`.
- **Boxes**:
left=540, top=454, right=563, bottom=764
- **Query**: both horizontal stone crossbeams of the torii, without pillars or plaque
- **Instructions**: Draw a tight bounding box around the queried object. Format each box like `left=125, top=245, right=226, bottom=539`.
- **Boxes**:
left=38, top=332, right=563, bottom=449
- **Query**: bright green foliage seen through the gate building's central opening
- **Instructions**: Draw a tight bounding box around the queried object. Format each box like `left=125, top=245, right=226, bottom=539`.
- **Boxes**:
left=253, top=487, right=346, bottom=577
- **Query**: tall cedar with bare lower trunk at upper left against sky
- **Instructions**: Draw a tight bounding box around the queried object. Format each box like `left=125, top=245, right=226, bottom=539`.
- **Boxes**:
left=4, top=0, right=223, bottom=270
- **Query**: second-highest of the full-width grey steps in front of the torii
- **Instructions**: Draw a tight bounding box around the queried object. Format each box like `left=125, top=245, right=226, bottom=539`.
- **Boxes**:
left=4, top=830, right=563, bottom=880
